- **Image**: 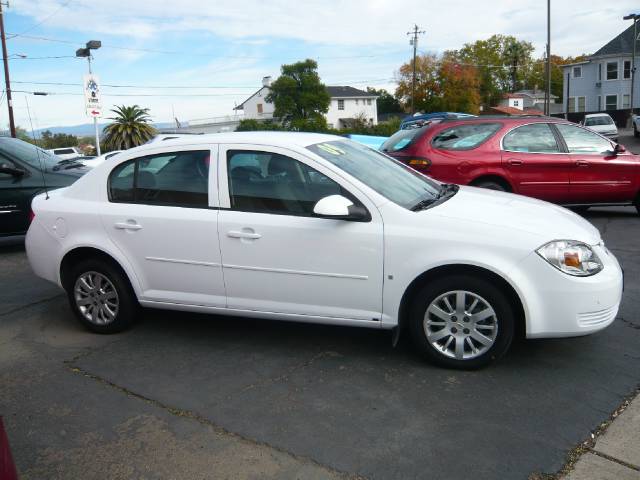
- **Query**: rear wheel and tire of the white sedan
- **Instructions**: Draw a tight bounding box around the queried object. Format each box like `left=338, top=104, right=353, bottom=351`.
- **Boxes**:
left=66, top=259, right=139, bottom=334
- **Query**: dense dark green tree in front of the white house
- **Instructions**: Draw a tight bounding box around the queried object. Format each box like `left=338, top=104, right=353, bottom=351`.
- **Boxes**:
left=265, top=59, right=331, bottom=131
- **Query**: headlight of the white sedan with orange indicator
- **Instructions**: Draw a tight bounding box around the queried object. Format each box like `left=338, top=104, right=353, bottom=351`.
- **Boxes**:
left=536, top=240, right=603, bottom=277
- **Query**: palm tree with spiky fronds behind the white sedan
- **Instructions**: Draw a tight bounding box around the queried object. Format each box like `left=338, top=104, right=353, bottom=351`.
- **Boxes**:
left=103, top=105, right=156, bottom=150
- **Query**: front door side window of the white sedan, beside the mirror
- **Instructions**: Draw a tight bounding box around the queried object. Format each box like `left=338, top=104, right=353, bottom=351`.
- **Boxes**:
left=227, top=150, right=348, bottom=216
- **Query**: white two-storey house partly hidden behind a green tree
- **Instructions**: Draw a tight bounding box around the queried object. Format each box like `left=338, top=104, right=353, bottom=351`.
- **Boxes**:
left=234, top=77, right=378, bottom=129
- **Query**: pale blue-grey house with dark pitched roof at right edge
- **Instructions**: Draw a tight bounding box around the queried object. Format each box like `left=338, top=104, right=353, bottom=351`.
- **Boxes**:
left=563, top=25, right=640, bottom=113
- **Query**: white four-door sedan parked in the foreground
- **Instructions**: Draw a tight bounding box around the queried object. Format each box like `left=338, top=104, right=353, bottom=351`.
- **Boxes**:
left=26, top=132, right=623, bottom=368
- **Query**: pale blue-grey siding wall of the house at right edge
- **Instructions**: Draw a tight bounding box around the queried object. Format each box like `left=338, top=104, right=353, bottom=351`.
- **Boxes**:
left=563, top=55, right=640, bottom=112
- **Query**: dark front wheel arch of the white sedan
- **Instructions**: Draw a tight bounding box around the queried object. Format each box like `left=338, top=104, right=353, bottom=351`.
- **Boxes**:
left=395, top=264, right=527, bottom=341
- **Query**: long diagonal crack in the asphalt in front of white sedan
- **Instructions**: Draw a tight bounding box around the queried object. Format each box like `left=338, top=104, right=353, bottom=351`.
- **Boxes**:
left=64, top=362, right=366, bottom=480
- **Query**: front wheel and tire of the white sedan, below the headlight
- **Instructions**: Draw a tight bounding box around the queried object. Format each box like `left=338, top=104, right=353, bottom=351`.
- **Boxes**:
left=409, top=275, right=515, bottom=369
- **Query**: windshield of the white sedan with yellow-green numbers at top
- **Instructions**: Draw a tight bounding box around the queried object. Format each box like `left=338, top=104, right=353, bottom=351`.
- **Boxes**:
left=307, top=140, right=441, bottom=209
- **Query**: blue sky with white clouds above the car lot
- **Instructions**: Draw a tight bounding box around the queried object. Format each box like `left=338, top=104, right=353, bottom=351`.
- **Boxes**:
left=5, top=0, right=638, bottom=130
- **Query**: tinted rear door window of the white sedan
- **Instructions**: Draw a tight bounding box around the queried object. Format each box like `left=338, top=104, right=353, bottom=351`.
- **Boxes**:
left=109, top=150, right=210, bottom=207
